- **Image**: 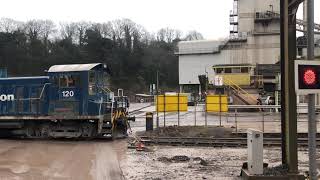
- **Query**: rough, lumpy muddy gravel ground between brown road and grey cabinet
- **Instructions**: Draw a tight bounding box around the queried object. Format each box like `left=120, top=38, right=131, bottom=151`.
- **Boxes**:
left=122, top=146, right=320, bottom=180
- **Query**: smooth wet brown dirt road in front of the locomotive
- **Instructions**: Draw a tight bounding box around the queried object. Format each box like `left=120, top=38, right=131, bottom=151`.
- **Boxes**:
left=0, top=140, right=127, bottom=180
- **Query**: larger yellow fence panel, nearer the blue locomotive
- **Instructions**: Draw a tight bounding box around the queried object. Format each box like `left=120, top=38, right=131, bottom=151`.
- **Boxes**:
left=155, top=94, right=188, bottom=112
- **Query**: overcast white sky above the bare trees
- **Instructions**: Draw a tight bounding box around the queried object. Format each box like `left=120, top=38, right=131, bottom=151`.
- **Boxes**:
left=0, top=0, right=320, bottom=39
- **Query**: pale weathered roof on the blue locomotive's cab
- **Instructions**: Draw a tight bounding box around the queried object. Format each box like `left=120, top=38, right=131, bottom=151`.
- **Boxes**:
left=48, top=63, right=106, bottom=73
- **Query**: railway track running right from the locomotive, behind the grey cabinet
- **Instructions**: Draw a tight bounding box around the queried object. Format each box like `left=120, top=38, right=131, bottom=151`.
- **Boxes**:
left=140, top=136, right=320, bottom=147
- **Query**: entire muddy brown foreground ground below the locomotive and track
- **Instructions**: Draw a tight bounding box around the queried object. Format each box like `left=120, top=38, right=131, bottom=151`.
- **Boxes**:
left=0, top=139, right=318, bottom=180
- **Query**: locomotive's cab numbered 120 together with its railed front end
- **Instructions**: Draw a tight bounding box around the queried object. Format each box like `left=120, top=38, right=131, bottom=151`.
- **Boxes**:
left=48, top=63, right=129, bottom=138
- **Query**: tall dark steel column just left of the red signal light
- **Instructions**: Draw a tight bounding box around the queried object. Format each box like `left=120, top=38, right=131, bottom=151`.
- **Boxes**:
left=280, top=0, right=298, bottom=174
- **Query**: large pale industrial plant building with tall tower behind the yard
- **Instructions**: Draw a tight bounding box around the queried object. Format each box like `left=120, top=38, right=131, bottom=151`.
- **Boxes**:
left=176, top=0, right=320, bottom=105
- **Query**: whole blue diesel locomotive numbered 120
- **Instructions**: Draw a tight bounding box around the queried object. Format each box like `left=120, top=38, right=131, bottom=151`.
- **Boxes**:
left=0, top=63, right=134, bottom=138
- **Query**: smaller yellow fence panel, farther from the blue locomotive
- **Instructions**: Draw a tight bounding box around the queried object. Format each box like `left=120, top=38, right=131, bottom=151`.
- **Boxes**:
left=206, top=95, right=228, bottom=112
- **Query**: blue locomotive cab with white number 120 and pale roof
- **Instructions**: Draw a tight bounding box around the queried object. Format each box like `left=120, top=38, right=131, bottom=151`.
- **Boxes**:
left=48, top=63, right=112, bottom=116
